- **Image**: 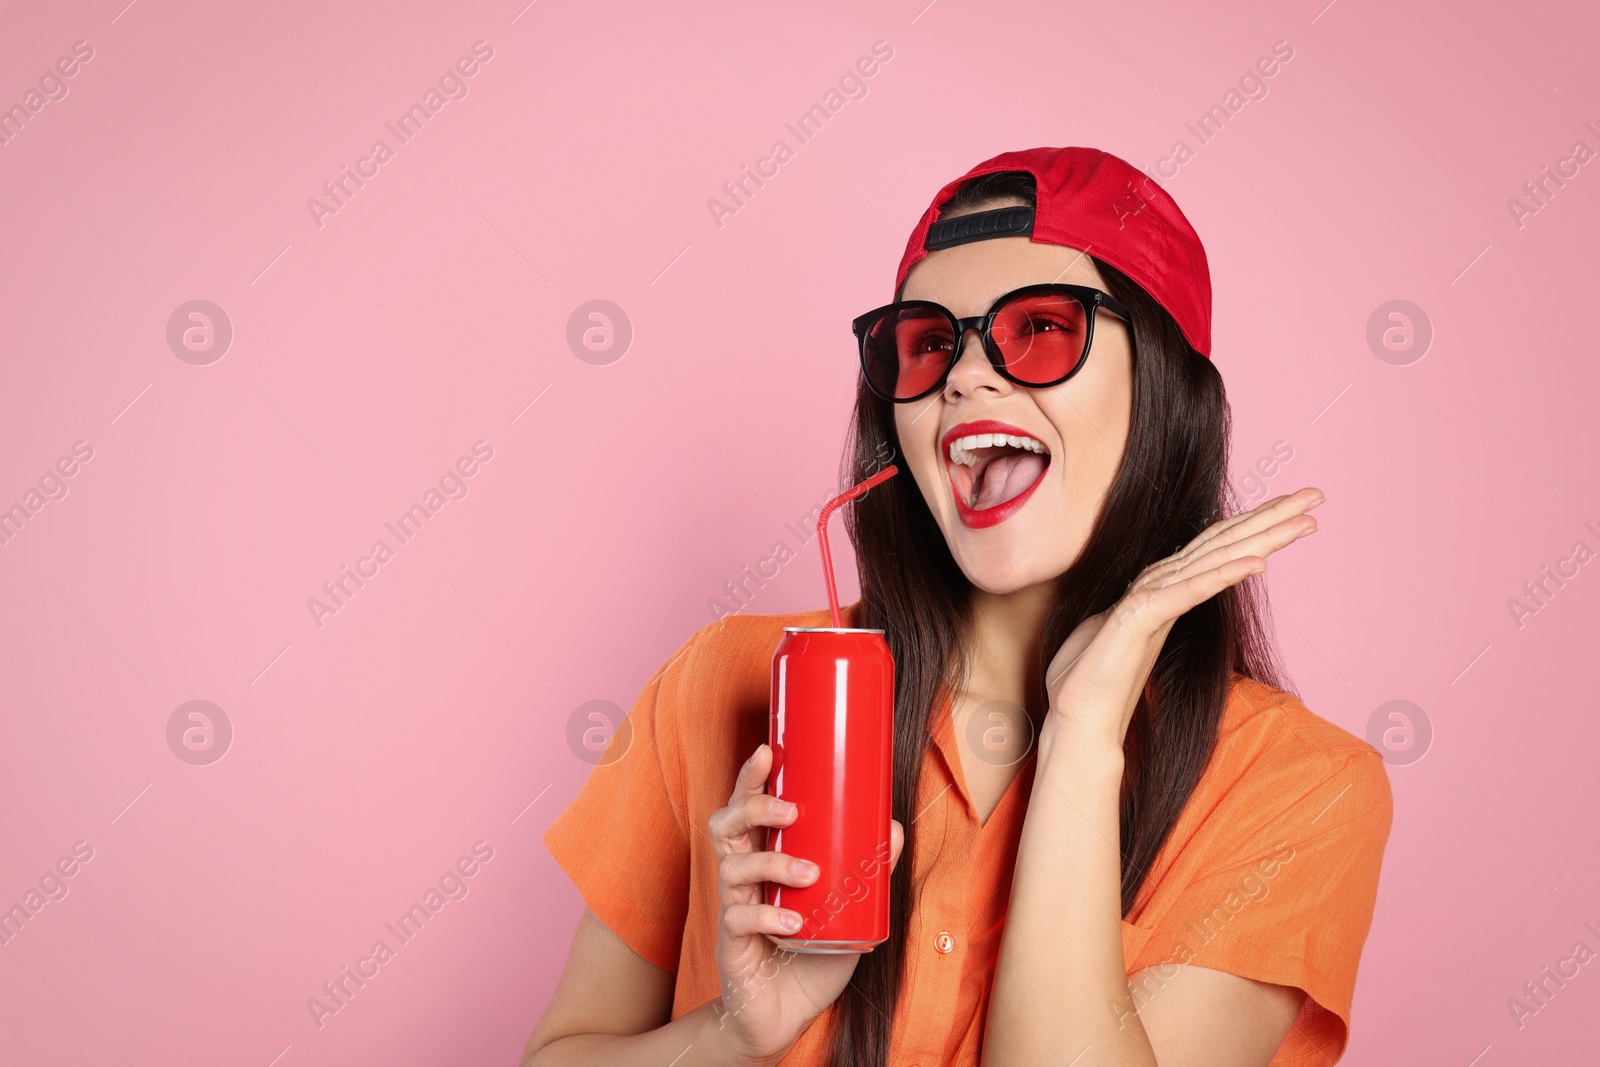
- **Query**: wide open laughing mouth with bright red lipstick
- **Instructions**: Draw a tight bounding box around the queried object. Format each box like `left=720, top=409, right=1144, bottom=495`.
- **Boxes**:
left=942, top=419, right=1050, bottom=530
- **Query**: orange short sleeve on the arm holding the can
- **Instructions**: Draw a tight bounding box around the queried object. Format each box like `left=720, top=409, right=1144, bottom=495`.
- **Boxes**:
left=544, top=638, right=693, bottom=973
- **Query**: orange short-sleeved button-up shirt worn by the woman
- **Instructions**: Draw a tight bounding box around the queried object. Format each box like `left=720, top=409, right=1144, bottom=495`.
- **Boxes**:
left=544, top=609, right=1392, bottom=1067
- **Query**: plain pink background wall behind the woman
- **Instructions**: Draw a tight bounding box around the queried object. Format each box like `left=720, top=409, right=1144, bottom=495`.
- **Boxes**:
left=0, top=0, right=1600, bottom=1067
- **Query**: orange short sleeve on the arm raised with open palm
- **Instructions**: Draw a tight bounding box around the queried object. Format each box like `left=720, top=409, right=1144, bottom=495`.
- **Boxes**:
left=1125, top=745, right=1394, bottom=1067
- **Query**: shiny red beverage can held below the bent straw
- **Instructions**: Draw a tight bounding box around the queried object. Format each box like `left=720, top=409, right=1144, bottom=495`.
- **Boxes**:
left=765, top=625, right=894, bottom=952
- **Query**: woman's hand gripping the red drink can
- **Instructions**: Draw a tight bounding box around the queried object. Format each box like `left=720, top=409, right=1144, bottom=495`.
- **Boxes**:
left=707, top=744, right=906, bottom=1067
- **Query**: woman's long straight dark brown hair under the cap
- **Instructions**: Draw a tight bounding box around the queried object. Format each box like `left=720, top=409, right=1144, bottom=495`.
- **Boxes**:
left=834, top=171, right=1286, bottom=1067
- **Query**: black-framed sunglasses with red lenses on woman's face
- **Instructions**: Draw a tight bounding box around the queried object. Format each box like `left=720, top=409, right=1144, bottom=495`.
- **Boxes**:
left=851, top=283, right=1131, bottom=403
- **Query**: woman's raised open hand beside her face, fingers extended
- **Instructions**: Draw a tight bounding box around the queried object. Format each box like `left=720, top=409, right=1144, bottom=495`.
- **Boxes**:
left=1040, top=488, right=1323, bottom=752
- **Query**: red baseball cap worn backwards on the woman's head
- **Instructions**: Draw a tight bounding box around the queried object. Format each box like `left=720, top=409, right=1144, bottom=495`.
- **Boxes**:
left=894, top=147, right=1211, bottom=357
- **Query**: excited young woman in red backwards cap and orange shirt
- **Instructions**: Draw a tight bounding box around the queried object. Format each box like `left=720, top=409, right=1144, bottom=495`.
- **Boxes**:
left=528, top=149, right=1392, bottom=1067
